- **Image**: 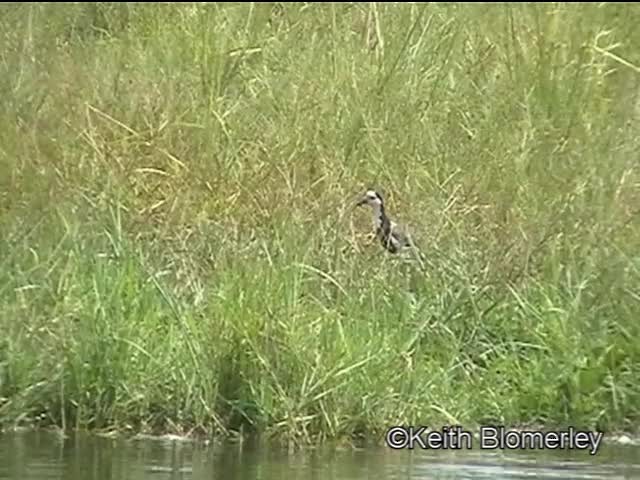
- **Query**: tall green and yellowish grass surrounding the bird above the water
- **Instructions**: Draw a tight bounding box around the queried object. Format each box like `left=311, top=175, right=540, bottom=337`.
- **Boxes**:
left=0, top=3, right=640, bottom=443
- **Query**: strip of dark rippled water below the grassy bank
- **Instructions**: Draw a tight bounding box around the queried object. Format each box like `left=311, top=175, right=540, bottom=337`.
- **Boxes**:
left=0, top=432, right=640, bottom=480
